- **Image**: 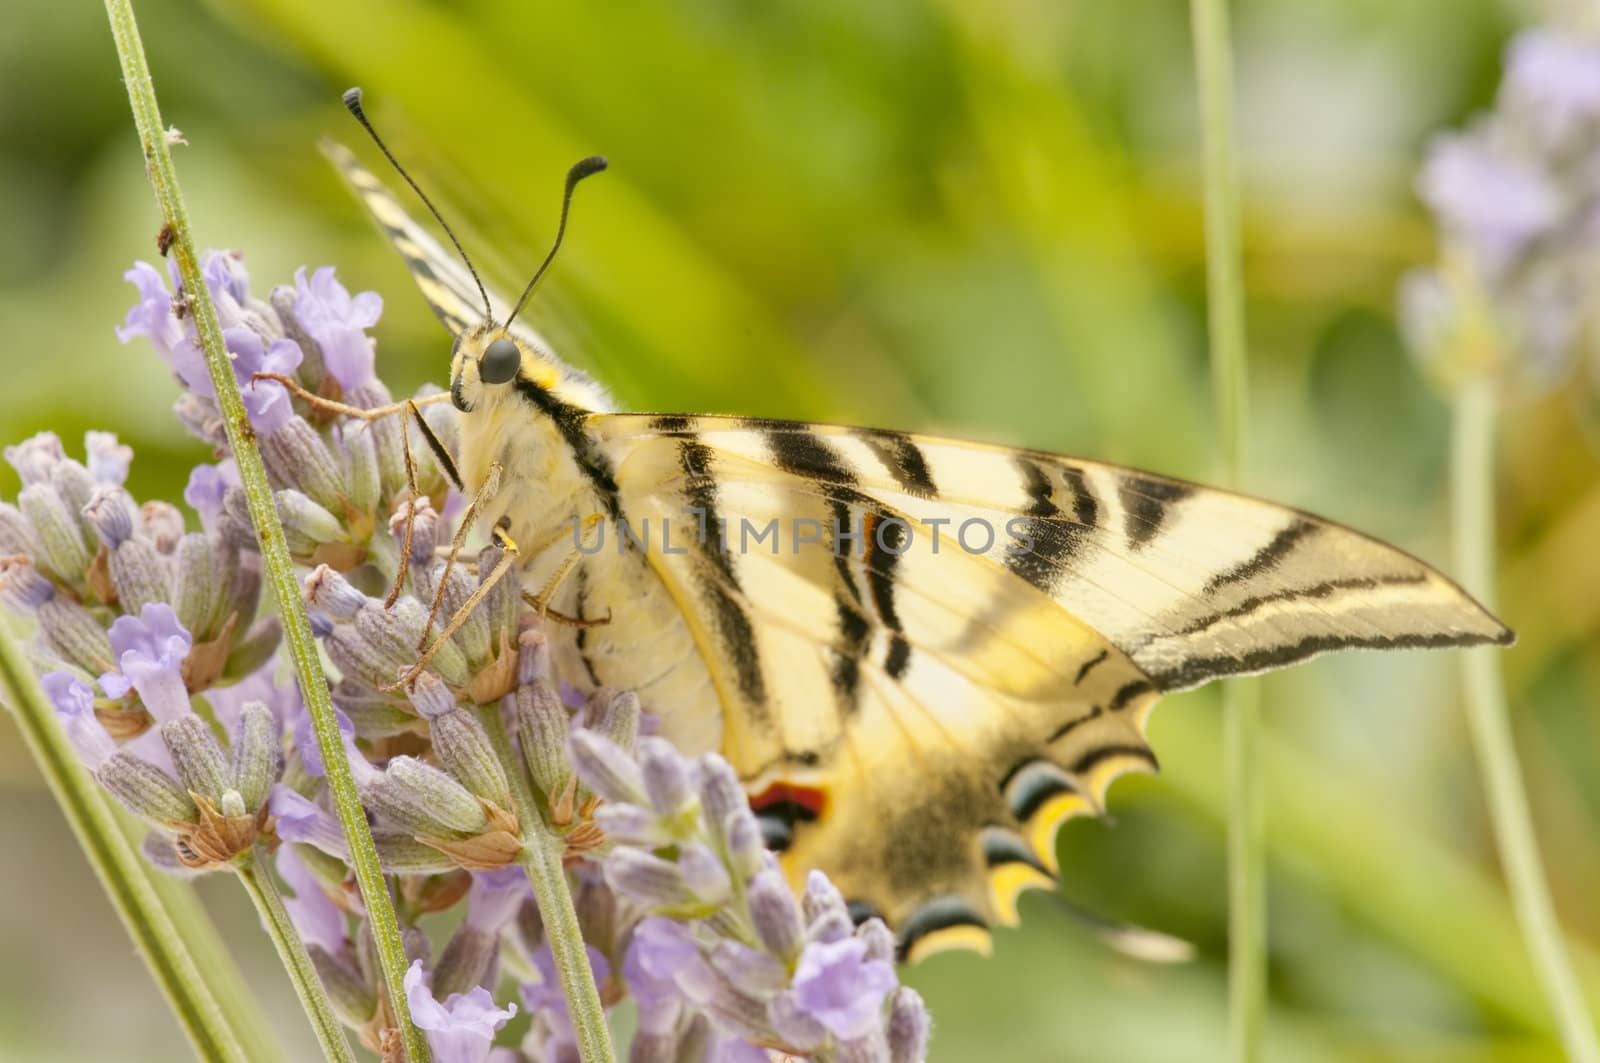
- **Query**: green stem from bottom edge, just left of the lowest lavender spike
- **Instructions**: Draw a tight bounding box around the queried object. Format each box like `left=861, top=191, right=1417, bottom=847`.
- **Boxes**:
left=478, top=706, right=616, bottom=1063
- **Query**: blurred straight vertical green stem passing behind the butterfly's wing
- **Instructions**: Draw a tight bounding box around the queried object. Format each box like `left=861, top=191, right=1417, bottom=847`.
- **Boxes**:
left=1190, top=0, right=1267, bottom=1063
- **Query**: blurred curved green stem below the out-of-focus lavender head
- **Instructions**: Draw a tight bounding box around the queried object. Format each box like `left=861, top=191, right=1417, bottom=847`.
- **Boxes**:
left=1451, top=378, right=1600, bottom=1063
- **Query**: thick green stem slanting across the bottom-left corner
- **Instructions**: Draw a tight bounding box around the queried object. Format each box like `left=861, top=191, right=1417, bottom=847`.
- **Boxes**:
left=0, top=624, right=250, bottom=1063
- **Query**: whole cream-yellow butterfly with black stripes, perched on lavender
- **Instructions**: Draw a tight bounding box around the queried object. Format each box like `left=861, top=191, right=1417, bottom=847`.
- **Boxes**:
left=328, top=99, right=1512, bottom=961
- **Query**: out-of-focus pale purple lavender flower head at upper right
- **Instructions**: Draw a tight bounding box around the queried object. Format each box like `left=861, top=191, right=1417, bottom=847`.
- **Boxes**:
left=1398, top=21, right=1600, bottom=392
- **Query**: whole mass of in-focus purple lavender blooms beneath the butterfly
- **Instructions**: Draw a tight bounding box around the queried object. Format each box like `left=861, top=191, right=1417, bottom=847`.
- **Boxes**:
left=0, top=253, right=928, bottom=1063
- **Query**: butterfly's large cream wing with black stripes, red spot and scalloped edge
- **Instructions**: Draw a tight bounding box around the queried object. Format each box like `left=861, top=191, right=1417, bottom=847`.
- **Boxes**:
left=589, top=415, right=1510, bottom=956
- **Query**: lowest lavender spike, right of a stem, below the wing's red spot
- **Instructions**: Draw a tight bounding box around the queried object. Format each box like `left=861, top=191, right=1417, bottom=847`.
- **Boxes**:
left=568, top=730, right=926, bottom=1060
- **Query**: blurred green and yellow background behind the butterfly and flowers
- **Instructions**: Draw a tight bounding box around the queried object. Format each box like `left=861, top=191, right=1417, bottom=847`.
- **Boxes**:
left=0, top=0, right=1600, bottom=1063
